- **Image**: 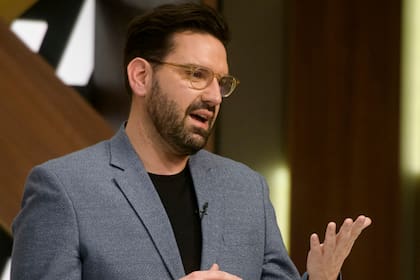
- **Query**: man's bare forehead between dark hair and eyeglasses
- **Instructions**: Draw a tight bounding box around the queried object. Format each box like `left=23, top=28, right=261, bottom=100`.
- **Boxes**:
left=167, top=31, right=228, bottom=73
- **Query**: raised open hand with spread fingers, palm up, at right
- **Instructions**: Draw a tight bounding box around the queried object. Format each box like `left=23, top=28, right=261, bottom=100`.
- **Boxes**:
left=306, top=215, right=372, bottom=280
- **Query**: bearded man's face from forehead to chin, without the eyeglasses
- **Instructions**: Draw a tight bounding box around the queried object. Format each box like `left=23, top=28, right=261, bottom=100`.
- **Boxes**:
left=146, top=32, right=228, bottom=155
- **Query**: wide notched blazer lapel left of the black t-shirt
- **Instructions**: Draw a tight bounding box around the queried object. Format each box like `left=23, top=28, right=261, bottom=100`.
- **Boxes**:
left=110, top=128, right=185, bottom=279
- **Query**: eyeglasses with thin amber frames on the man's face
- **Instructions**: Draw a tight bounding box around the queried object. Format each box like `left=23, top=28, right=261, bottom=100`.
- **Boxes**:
left=149, top=59, right=239, bottom=97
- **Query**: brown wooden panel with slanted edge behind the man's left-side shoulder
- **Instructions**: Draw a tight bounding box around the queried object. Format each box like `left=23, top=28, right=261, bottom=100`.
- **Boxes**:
left=0, top=18, right=113, bottom=230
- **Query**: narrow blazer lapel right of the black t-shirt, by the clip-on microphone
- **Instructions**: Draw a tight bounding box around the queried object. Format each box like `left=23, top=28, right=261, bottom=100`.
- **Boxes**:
left=189, top=152, right=224, bottom=270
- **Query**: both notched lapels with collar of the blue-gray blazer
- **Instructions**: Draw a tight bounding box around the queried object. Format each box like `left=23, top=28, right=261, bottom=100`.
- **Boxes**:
left=110, top=126, right=224, bottom=279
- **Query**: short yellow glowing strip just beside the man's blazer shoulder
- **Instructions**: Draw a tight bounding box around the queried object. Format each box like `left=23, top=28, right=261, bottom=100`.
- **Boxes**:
left=267, top=165, right=290, bottom=249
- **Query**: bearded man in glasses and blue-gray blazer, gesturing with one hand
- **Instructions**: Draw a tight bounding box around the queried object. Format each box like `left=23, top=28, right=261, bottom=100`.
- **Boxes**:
left=12, top=4, right=370, bottom=280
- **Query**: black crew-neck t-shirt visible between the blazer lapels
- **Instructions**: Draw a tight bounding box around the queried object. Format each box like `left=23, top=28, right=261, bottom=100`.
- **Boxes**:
left=149, top=167, right=202, bottom=274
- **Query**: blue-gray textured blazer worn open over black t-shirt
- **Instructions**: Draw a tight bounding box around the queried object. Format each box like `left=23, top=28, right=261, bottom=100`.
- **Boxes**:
left=11, top=128, right=300, bottom=280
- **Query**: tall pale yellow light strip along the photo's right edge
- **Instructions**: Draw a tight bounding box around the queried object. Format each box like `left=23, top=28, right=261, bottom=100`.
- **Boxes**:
left=401, top=0, right=420, bottom=176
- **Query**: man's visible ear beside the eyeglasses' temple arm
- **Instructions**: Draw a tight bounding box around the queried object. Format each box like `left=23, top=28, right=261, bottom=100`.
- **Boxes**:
left=127, top=57, right=152, bottom=96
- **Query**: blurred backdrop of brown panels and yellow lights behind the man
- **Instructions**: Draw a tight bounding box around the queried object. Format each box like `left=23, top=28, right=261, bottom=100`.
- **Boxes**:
left=0, top=0, right=420, bottom=280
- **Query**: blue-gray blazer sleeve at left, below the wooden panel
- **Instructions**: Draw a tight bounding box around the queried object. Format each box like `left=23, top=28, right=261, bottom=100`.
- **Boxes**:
left=11, top=166, right=82, bottom=280
